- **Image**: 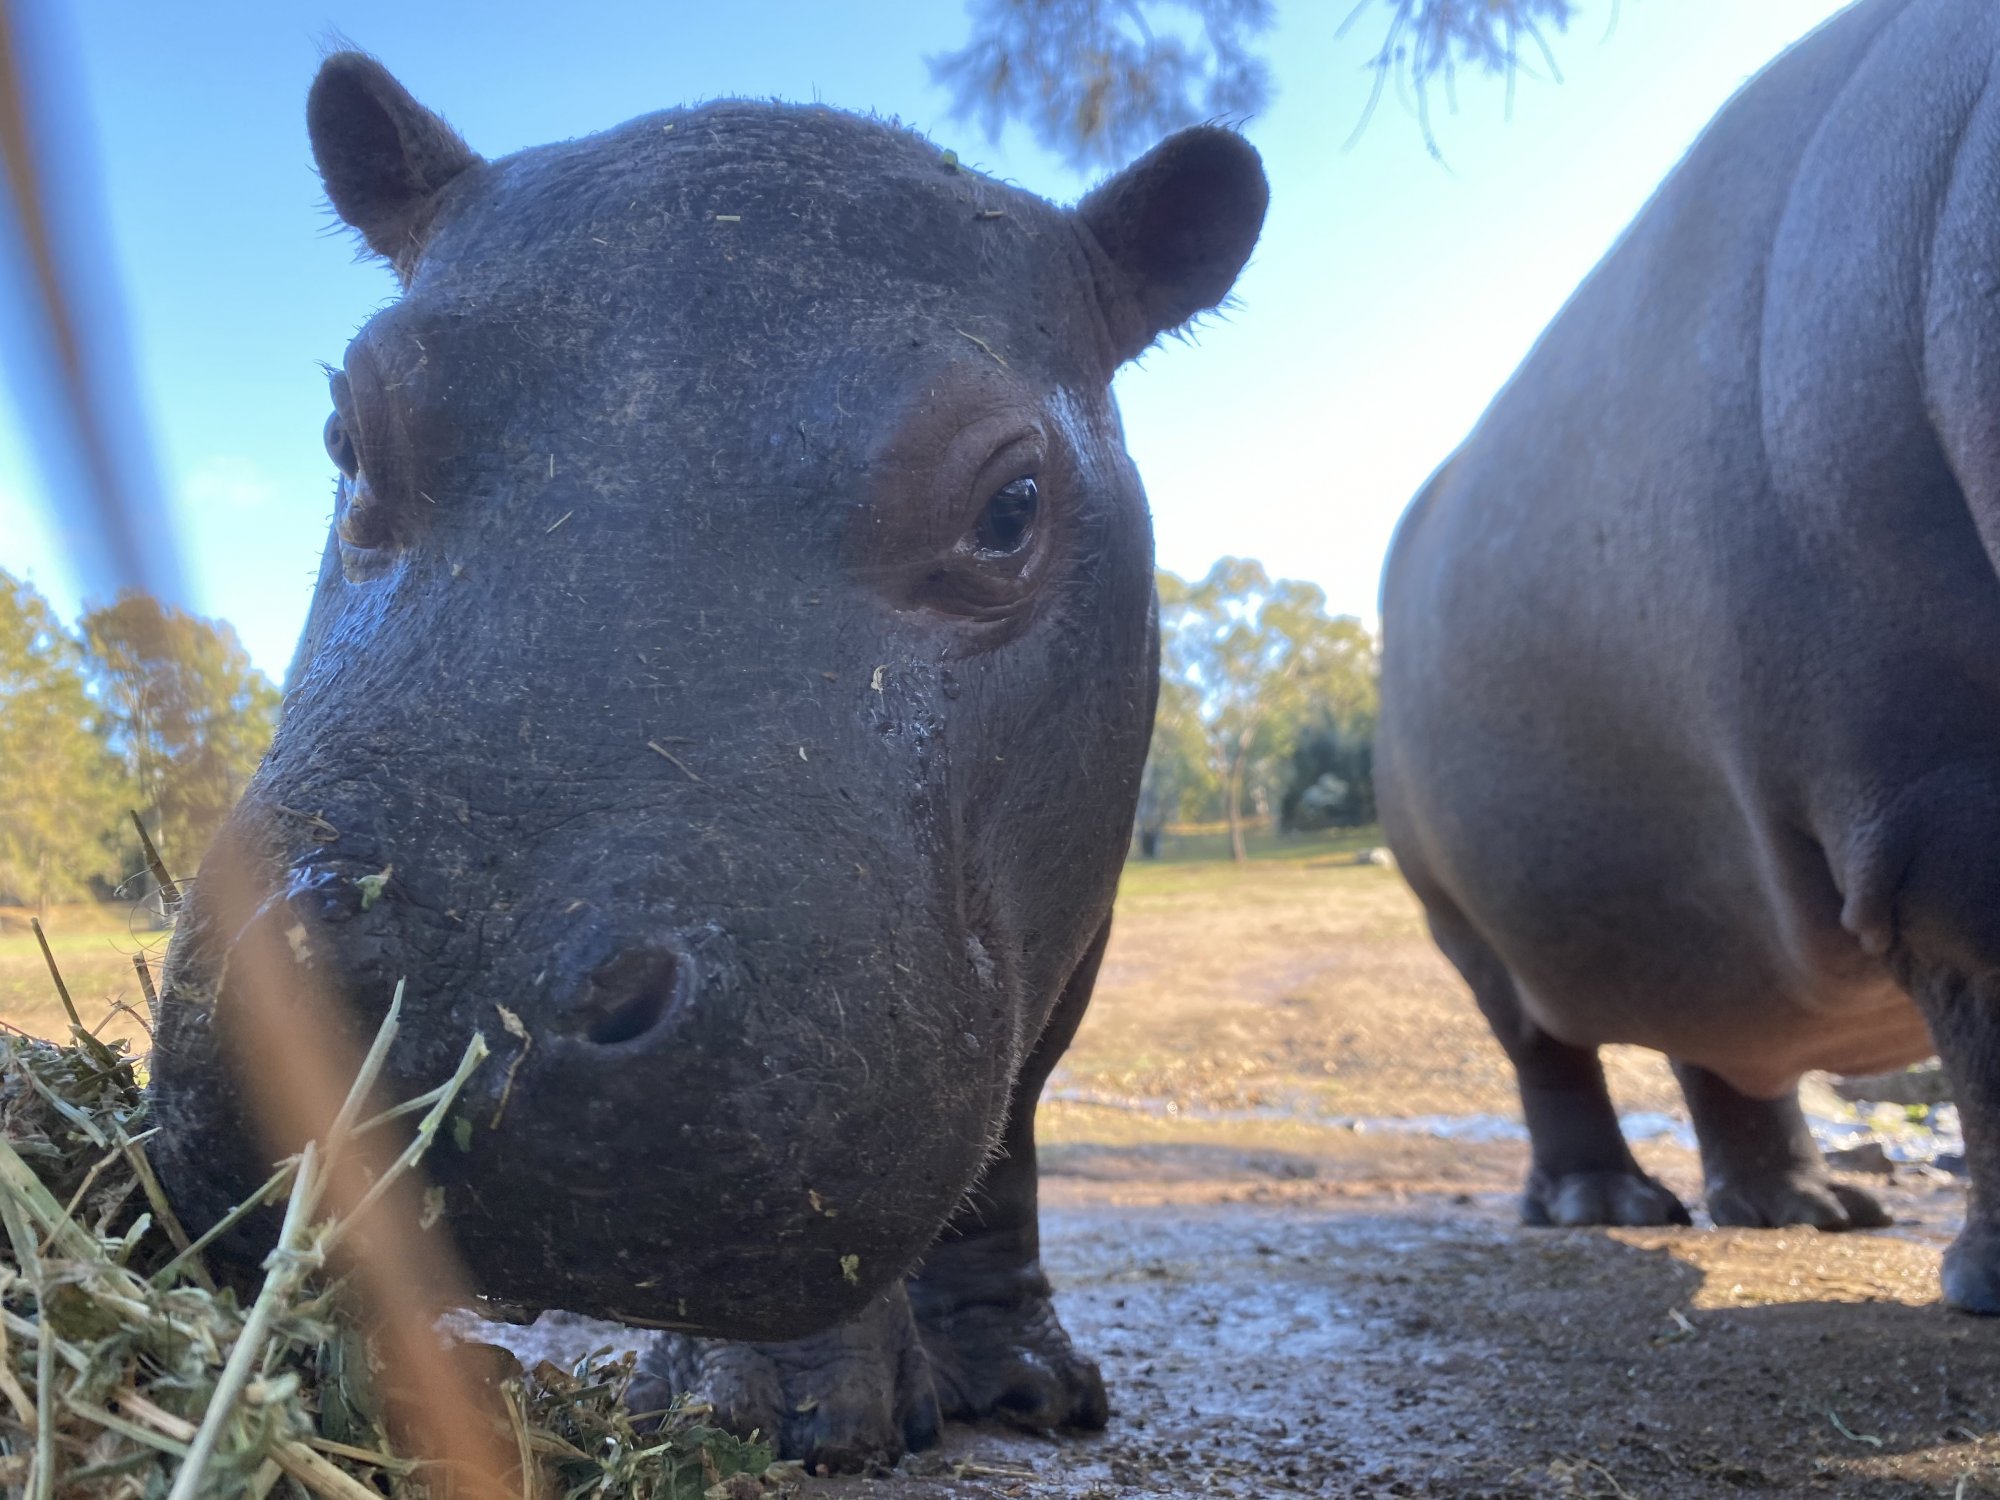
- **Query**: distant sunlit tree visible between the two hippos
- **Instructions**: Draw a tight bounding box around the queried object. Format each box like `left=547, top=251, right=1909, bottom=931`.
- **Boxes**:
left=1156, top=558, right=1378, bottom=860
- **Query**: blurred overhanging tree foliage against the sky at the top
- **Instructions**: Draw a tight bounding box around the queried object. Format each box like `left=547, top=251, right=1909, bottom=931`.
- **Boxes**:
left=930, top=0, right=1576, bottom=168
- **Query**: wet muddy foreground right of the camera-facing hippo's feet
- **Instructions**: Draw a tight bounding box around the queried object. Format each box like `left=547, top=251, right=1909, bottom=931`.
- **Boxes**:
left=806, top=1150, right=2000, bottom=1500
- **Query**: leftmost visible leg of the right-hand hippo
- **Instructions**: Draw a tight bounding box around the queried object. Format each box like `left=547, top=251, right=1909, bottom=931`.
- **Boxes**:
left=1420, top=892, right=1690, bottom=1224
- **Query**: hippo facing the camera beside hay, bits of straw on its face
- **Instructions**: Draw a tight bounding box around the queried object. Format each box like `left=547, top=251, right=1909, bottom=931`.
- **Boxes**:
left=154, top=52, right=1266, bottom=1466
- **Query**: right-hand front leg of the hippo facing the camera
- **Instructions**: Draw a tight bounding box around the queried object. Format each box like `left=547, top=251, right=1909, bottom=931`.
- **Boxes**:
left=910, top=922, right=1110, bottom=1430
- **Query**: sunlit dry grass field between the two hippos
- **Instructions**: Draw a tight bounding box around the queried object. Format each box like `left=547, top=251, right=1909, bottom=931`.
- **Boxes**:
left=1052, top=838, right=1680, bottom=1130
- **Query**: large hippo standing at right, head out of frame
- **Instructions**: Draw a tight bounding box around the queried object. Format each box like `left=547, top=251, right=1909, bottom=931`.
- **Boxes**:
left=1380, top=0, right=2000, bottom=1312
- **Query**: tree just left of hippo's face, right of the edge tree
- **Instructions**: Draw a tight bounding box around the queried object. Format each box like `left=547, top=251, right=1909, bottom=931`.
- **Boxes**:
left=82, top=592, right=278, bottom=868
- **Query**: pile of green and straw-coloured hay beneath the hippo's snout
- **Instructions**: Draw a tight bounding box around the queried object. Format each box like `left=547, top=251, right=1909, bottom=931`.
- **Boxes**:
left=0, top=1016, right=776, bottom=1500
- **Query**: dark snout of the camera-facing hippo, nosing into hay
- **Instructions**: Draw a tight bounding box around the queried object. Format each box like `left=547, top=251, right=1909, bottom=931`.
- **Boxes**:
left=154, top=840, right=1014, bottom=1338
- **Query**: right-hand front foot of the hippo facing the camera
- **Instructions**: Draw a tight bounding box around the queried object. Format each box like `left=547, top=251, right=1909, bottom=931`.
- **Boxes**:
left=910, top=1258, right=1110, bottom=1432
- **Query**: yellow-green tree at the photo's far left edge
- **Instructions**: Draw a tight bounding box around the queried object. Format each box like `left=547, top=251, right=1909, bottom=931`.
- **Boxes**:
left=0, top=572, right=128, bottom=908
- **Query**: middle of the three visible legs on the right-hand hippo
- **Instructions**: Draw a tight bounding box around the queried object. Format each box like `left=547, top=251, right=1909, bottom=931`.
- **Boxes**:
left=1674, top=1060, right=1890, bottom=1230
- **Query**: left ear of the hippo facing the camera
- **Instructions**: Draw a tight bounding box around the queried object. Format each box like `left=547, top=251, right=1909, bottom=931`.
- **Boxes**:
left=306, top=52, right=480, bottom=280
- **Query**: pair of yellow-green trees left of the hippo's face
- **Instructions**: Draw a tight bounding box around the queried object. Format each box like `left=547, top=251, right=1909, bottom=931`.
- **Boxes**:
left=0, top=572, right=278, bottom=908
